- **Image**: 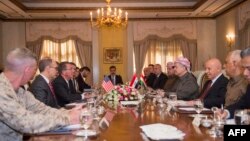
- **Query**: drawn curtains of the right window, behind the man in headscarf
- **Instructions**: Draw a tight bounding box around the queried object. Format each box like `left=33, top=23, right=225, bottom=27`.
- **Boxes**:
left=134, top=35, right=197, bottom=73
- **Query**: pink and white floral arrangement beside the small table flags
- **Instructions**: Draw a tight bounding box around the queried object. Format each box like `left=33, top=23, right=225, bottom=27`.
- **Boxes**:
left=104, top=85, right=139, bottom=101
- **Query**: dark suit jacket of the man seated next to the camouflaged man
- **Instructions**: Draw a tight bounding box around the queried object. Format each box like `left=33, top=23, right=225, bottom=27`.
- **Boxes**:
left=29, top=75, right=60, bottom=108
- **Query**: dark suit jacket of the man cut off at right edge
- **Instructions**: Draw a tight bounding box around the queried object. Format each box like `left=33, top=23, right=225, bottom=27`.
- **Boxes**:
left=227, top=84, right=250, bottom=118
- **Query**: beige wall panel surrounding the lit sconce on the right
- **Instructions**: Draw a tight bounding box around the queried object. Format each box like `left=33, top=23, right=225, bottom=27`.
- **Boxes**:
left=216, top=8, right=238, bottom=62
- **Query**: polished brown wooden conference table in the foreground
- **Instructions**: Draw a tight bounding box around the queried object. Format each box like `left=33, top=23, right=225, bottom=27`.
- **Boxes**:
left=28, top=101, right=223, bottom=141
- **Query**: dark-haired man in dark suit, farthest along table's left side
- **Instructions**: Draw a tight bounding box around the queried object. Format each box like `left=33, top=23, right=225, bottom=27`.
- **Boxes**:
left=76, top=66, right=91, bottom=92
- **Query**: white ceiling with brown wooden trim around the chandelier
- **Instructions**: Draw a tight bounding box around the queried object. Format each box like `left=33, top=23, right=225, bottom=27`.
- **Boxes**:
left=0, top=0, right=246, bottom=20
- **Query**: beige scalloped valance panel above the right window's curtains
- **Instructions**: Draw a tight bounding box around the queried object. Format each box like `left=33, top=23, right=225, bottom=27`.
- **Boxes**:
left=134, top=20, right=197, bottom=41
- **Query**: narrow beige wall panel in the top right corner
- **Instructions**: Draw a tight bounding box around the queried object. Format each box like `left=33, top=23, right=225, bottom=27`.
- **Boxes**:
left=238, top=1, right=250, bottom=29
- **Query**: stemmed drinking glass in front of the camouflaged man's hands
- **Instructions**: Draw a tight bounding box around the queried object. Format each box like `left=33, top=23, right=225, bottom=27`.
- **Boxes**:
left=80, top=109, right=93, bottom=137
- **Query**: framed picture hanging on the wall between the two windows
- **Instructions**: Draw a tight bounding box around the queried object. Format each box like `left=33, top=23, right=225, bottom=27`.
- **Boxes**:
left=103, top=47, right=122, bottom=64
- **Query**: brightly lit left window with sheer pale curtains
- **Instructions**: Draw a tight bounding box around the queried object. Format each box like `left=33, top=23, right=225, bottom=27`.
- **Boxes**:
left=41, top=40, right=81, bottom=67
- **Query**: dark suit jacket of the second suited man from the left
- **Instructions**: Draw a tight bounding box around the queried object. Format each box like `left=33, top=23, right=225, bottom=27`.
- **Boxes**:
left=53, top=75, right=82, bottom=106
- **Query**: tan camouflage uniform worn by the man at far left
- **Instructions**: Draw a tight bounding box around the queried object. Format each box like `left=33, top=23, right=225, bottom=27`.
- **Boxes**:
left=0, top=73, right=69, bottom=141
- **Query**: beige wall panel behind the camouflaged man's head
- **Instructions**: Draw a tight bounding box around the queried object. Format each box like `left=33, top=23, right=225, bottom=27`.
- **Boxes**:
left=2, top=22, right=25, bottom=64
